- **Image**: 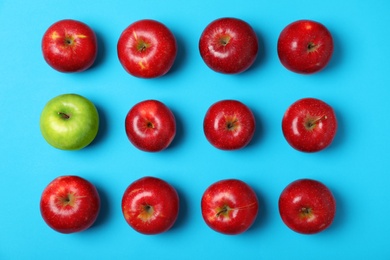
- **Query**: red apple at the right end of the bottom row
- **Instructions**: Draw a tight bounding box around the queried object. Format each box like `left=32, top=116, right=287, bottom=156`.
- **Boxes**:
left=279, top=179, right=336, bottom=234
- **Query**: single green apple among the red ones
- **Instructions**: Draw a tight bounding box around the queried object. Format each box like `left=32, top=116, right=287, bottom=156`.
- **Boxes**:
left=40, top=94, right=99, bottom=150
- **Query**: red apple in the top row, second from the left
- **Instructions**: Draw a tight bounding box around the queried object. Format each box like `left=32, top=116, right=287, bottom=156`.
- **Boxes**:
left=117, top=20, right=177, bottom=78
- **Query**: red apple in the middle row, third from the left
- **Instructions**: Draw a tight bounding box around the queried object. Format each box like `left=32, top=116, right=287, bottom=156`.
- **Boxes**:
left=203, top=100, right=256, bottom=150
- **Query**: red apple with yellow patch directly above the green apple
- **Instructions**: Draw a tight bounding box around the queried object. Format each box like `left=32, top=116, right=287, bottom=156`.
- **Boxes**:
left=42, top=19, right=98, bottom=72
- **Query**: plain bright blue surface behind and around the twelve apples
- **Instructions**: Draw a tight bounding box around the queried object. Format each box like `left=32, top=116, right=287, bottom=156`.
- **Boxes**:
left=0, top=0, right=390, bottom=259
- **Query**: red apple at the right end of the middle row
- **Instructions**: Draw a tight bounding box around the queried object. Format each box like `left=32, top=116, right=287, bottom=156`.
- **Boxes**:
left=282, top=98, right=337, bottom=152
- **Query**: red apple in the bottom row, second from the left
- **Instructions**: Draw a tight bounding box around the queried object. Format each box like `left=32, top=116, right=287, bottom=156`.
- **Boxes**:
left=122, top=176, right=179, bottom=235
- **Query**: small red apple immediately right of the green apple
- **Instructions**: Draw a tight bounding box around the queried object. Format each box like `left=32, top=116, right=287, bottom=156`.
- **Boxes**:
left=125, top=100, right=176, bottom=152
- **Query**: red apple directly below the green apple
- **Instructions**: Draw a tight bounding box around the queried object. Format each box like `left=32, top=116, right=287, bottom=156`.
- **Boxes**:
left=40, top=175, right=100, bottom=234
